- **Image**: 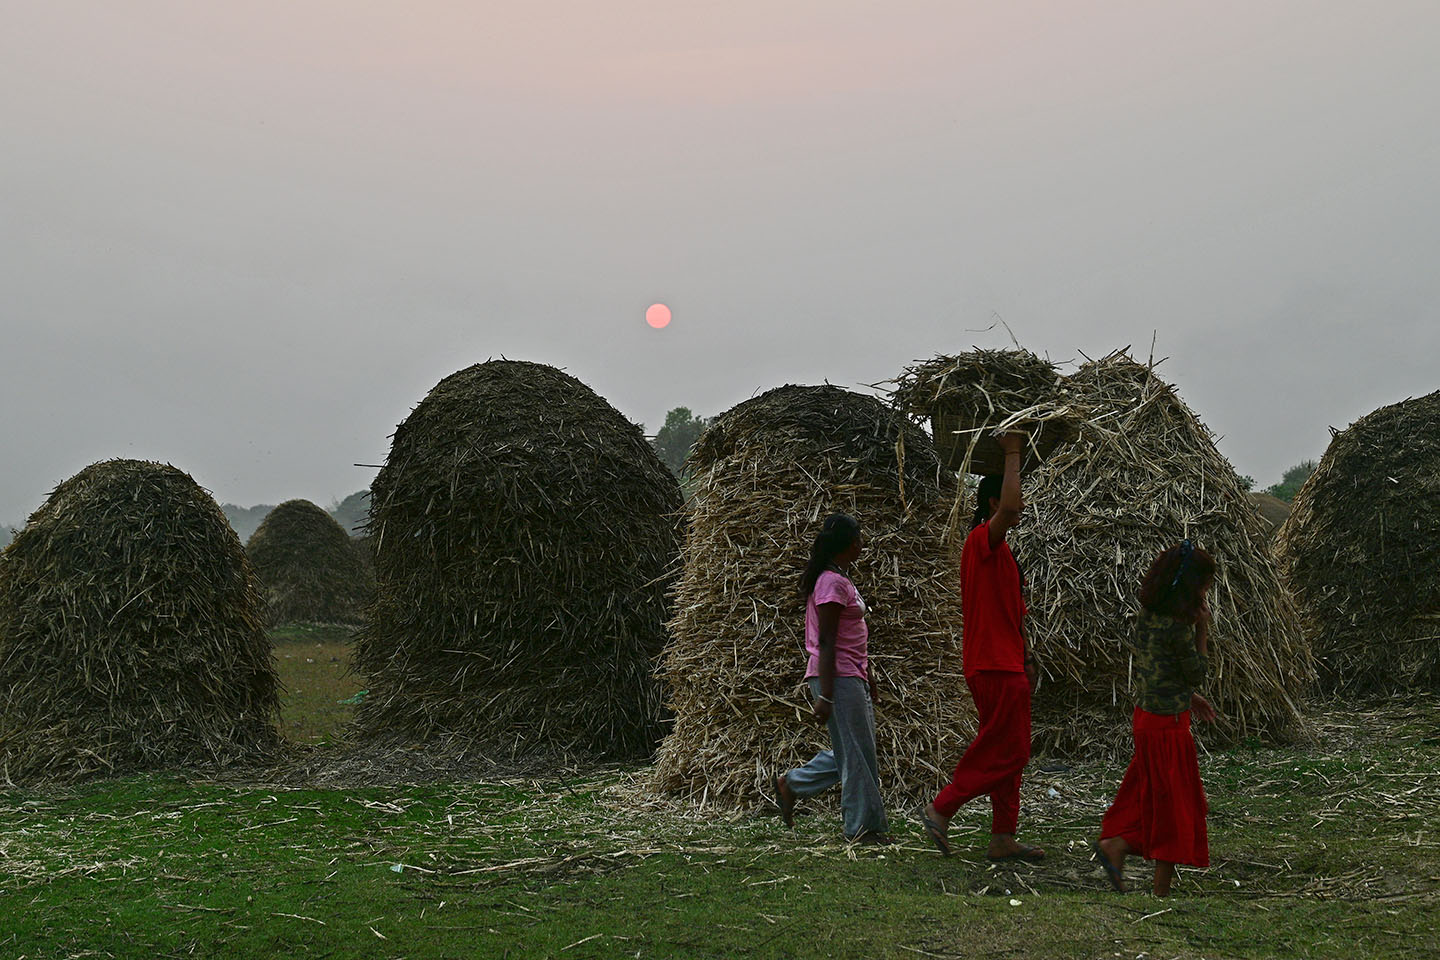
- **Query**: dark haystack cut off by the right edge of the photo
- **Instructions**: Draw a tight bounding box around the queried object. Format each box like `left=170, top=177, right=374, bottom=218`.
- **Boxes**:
left=1276, top=391, right=1440, bottom=692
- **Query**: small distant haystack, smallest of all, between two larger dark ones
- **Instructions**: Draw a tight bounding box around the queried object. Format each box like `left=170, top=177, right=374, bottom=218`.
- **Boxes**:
left=245, top=499, right=374, bottom=626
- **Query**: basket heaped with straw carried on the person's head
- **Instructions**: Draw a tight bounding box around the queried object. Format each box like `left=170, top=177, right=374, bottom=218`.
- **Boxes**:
left=890, top=350, right=1080, bottom=474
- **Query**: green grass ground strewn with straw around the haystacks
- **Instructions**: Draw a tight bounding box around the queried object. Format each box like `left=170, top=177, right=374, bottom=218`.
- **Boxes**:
left=0, top=632, right=1440, bottom=960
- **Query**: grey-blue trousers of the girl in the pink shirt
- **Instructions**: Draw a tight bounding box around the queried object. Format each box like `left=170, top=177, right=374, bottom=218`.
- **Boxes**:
left=785, top=676, right=888, bottom=839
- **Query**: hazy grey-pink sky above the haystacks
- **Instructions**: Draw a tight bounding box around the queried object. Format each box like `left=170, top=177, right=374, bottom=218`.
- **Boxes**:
left=0, top=0, right=1440, bottom=522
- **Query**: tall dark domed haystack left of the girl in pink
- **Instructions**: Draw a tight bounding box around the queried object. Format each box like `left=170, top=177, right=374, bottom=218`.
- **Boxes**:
left=356, top=360, right=680, bottom=756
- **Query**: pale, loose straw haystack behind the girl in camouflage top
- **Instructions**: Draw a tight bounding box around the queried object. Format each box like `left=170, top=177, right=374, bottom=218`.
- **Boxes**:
left=1012, top=353, right=1313, bottom=751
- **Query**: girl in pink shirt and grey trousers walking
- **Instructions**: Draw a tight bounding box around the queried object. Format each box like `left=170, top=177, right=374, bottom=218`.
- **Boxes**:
left=775, top=514, right=890, bottom=843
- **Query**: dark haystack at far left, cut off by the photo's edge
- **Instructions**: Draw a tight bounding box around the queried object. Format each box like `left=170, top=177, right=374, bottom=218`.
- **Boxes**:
left=0, top=461, right=279, bottom=782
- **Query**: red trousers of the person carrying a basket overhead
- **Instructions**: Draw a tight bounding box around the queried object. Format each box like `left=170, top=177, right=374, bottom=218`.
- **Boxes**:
left=935, top=671, right=1030, bottom=833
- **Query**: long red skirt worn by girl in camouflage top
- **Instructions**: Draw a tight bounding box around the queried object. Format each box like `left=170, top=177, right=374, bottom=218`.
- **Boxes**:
left=1100, top=707, right=1210, bottom=866
